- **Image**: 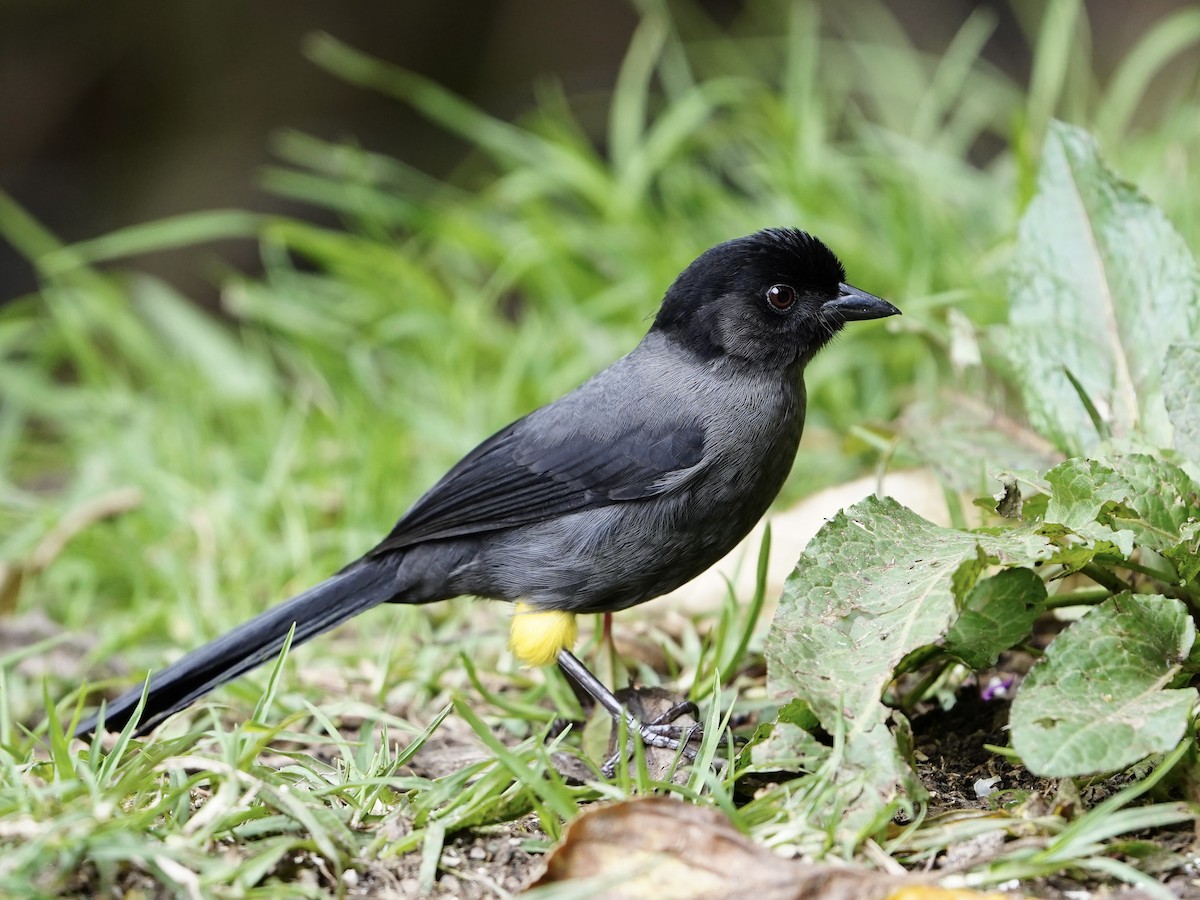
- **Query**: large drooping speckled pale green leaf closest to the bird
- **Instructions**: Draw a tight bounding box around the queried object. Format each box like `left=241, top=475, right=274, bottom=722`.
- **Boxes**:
left=755, top=498, right=1054, bottom=821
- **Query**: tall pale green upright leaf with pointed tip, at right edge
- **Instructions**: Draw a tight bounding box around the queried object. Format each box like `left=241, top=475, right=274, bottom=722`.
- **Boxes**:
left=1006, top=122, right=1200, bottom=455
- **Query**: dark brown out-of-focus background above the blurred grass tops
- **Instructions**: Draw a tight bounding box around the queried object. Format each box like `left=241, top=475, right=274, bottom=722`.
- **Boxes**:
left=0, top=0, right=1184, bottom=302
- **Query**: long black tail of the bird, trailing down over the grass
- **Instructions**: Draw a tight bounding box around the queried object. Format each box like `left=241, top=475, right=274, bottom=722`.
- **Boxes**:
left=74, top=558, right=396, bottom=738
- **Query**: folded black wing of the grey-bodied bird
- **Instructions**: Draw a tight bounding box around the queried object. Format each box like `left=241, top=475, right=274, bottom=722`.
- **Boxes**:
left=372, top=416, right=704, bottom=556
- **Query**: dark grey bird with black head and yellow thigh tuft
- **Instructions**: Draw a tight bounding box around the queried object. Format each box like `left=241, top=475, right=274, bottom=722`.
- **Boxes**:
left=74, top=228, right=900, bottom=749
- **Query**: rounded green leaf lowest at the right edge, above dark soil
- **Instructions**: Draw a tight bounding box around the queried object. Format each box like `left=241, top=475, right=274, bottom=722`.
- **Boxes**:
left=1010, top=593, right=1196, bottom=778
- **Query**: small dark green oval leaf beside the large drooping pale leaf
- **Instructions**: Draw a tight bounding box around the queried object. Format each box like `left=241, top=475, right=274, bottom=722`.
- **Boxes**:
left=946, top=568, right=1046, bottom=668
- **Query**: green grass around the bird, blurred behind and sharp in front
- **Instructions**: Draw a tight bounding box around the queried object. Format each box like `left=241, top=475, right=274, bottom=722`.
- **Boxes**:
left=0, top=2, right=1200, bottom=896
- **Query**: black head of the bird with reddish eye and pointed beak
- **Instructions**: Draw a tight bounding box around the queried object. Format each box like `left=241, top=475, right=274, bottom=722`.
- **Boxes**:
left=652, top=228, right=900, bottom=370
